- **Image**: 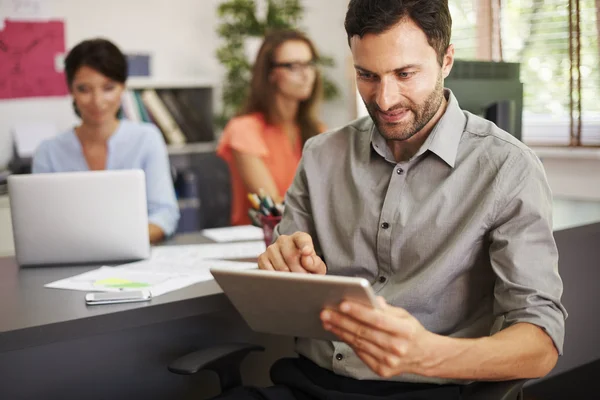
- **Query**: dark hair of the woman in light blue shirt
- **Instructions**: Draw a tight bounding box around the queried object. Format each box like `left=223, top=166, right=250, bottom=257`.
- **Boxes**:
left=65, top=39, right=127, bottom=88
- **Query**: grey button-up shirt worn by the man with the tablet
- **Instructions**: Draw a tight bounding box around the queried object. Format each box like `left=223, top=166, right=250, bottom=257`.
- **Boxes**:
left=276, top=90, right=566, bottom=383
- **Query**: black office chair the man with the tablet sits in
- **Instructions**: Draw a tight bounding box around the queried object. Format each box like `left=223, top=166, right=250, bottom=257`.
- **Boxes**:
left=168, top=343, right=527, bottom=400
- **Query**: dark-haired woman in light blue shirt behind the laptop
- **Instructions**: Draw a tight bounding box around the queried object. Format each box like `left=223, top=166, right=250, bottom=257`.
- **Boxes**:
left=32, top=39, right=179, bottom=243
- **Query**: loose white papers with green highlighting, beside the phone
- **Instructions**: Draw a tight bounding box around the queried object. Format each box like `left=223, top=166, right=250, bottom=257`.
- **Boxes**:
left=45, top=260, right=257, bottom=296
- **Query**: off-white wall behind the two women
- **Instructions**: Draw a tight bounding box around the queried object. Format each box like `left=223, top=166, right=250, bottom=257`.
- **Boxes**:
left=0, top=0, right=353, bottom=169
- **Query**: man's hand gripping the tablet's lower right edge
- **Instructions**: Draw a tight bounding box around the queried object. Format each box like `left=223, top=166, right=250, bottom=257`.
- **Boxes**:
left=321, top=297, right=437, bottom=378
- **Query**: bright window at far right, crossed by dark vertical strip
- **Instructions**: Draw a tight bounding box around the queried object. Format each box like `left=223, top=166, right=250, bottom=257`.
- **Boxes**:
left=500, top=0, right=600, bottom=145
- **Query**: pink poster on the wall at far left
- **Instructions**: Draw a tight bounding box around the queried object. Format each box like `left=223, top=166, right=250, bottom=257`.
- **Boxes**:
left=0, top=20, right=68, bottom=99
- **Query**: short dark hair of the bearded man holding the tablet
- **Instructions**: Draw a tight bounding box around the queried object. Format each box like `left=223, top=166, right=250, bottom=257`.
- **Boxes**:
left=344, top=0, right=452, bottom=65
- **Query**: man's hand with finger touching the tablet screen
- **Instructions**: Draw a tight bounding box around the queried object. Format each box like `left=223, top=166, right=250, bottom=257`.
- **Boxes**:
left=258, top=232, right=327, bottom=275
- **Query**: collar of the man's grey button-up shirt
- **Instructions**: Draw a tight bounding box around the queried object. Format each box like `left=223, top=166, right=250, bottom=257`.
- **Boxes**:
left=371, top=89, right=467, bottom=168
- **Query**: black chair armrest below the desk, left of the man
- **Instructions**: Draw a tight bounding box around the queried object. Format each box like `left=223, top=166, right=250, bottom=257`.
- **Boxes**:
left=168, top=343, right=265, bottom=392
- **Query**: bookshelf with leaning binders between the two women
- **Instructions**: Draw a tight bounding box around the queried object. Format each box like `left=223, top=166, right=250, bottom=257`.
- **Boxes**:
left=122, top=78, right=223, bottom=233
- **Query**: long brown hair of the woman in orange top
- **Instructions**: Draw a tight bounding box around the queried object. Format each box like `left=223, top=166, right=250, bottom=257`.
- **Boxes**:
left=240, top=30, right=323, bottom=143
